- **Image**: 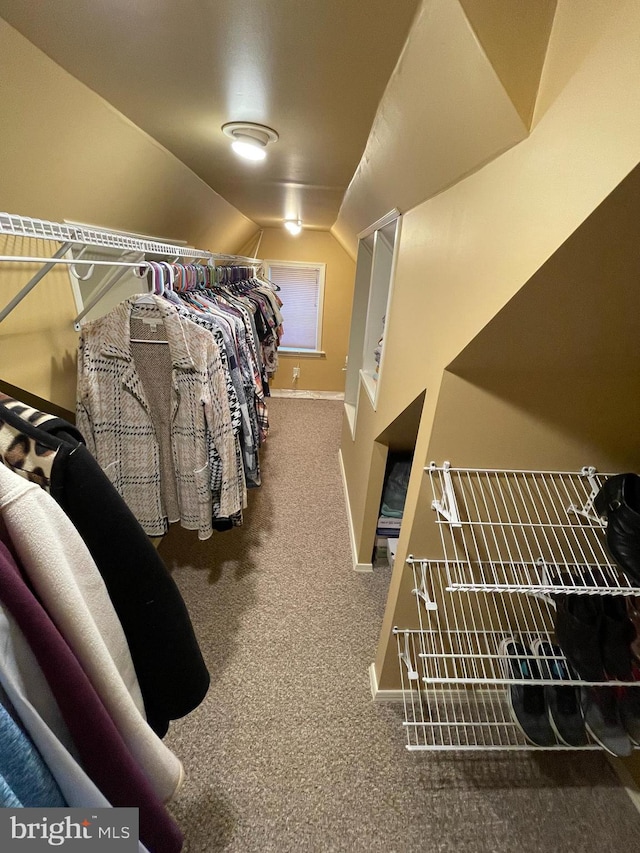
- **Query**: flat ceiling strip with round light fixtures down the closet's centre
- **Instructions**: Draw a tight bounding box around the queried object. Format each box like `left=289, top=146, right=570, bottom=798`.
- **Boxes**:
left=0, top=0, right=420, bottom=229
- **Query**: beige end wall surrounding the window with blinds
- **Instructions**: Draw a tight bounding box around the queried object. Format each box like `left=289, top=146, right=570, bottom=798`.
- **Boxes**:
left=259, top=223, right=355, bottom=392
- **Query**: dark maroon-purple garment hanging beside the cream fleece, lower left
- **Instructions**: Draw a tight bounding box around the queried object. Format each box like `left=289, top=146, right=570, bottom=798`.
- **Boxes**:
left=0, top=541, right=183, bottom=853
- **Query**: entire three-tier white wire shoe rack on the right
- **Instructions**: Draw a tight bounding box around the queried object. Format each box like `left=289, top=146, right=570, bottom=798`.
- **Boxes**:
left=394, top=463, right=640, bottom=750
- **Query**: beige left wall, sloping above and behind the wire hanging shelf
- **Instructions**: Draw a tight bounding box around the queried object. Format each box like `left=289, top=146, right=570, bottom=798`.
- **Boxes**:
left=0, top=20, right=255, bottom=409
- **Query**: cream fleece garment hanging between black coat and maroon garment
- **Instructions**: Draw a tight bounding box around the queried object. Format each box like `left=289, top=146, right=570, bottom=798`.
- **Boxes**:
left=0, top=465, right=183, bottom=800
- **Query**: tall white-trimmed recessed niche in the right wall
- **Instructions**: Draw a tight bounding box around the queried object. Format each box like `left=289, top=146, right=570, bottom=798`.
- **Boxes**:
left=345, top=210, right=400, bottom=434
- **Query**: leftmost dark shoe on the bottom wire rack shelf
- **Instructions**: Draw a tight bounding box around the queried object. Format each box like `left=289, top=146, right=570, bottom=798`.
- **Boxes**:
left=498, top=637, right=557, bottom=746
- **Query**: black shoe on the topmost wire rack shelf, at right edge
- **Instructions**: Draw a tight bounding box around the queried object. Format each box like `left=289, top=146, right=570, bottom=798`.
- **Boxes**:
left=593, top=474, right=640, bottom=583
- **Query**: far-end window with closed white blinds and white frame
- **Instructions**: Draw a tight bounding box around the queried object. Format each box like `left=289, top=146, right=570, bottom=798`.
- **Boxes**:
left=265, top=261, right=325, bottom=355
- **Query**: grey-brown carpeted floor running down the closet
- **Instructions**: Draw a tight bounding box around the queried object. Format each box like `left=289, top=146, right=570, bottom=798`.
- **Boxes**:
left=160, top=398, right=640, bottom=853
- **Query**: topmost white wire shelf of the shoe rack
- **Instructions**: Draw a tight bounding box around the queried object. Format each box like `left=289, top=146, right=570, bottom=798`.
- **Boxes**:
left=425, top=462, right=640, bottom=595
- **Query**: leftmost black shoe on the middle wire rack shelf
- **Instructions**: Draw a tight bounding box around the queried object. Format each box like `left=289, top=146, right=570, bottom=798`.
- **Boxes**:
left=554, top=595, right=607, bottom=681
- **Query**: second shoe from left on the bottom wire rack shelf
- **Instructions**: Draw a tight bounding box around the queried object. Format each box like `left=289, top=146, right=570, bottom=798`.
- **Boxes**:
left=531, top=637, right=587, bottom=746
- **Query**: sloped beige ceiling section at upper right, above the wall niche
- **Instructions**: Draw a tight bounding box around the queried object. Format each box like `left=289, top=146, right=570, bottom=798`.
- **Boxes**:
left=332, top=0, right=555, bottom=255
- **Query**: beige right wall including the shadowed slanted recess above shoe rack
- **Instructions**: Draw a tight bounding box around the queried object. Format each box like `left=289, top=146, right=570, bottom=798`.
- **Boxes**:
left=342, top=0, right=640, bottom=704
